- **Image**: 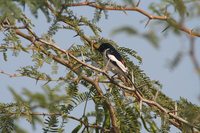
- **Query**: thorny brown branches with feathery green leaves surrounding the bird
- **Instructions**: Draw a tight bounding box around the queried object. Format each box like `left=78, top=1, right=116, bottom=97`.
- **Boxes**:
left=0, top=0, right=200, bottom=133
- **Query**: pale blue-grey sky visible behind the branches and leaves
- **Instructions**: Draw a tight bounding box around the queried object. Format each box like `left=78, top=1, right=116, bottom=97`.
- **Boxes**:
left=0, top=2, right=200, bottom=133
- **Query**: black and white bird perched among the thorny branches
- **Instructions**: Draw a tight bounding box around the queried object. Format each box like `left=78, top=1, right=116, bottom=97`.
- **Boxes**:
left=98, top=43, right=128, bottom=80
